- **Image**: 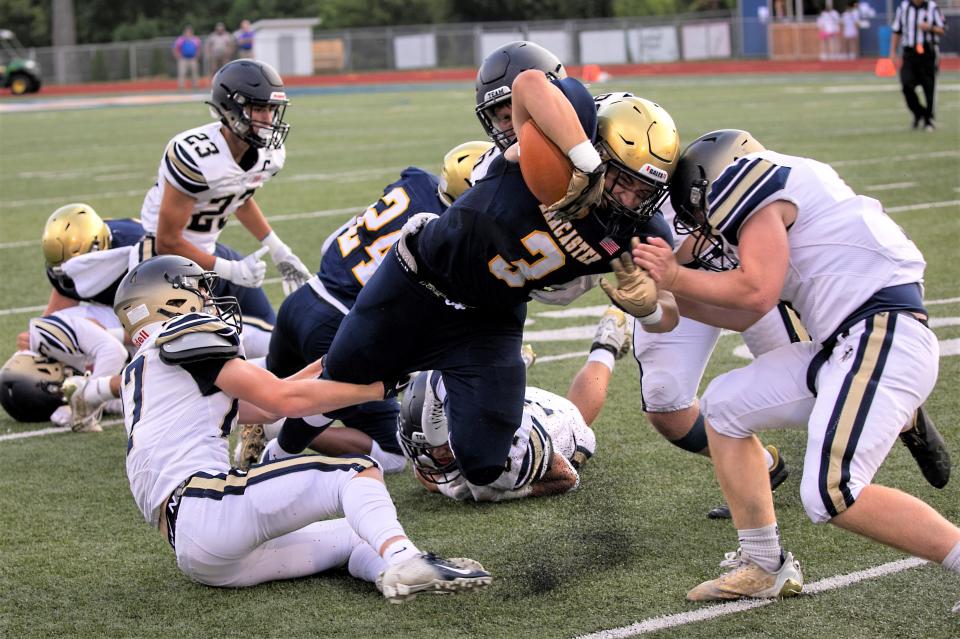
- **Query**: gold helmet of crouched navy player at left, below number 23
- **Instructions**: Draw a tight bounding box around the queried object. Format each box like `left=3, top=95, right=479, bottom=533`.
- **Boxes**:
left=40, top=203, right=110, bottom=267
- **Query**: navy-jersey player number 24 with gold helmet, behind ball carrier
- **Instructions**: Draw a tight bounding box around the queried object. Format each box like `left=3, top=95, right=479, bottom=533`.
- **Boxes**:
left=248, top=142, right=493, bottom=472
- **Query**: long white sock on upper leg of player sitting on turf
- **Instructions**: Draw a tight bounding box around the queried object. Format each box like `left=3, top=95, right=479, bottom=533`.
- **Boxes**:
left=340, top=477, right=420, bottom=564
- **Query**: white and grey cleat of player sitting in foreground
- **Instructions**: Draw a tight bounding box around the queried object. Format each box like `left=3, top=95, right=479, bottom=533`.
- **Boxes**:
left=377, top=553, right=493, bottom=604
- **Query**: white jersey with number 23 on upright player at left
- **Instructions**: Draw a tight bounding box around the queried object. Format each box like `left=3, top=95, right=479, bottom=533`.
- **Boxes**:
left=140, top=122, right=287, bottom=253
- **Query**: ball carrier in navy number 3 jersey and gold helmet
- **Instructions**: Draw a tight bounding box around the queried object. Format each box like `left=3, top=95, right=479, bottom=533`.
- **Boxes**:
left=324, top=70, right=679, bottom=486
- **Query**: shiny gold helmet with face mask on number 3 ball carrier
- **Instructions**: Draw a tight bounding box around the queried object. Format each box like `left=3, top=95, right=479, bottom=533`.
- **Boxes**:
left=597, top=95, right=680, bottom=233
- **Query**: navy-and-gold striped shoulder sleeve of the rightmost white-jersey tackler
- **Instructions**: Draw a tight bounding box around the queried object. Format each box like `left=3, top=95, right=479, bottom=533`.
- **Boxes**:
left=707, top=156, right=791, bottom=246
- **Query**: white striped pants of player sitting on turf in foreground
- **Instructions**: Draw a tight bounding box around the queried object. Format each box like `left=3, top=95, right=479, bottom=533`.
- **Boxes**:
left=172, top=455, right=376, bottom=587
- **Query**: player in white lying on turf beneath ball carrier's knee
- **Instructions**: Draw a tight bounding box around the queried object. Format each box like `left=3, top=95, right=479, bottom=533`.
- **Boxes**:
left=397, top=306, right=632, bottom=501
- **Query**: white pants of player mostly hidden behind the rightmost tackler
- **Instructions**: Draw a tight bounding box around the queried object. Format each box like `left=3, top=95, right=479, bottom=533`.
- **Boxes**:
left=633, top=303, right=810, bottom=413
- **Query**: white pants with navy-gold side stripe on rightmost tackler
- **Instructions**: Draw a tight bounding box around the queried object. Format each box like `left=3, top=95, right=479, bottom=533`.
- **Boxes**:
left=701, top=313, right=940, bottom=523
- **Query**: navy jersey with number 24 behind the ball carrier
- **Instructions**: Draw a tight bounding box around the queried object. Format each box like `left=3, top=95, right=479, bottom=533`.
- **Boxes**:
left=317, top=166, right=446, bottom=307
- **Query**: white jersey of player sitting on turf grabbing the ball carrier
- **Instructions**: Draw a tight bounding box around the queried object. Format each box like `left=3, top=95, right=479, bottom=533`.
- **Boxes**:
left=120, top=313, right=242, bottom=527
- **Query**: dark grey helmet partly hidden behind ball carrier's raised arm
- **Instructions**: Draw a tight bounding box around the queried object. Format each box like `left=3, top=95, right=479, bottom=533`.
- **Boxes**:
left=476, top=40, right=567, bottom=150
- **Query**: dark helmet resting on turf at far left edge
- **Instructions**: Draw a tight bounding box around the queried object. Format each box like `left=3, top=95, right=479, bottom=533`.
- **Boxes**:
left=0, top=351, right=70, bottom=422
